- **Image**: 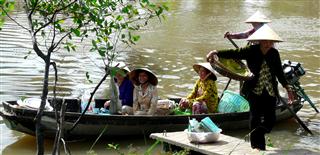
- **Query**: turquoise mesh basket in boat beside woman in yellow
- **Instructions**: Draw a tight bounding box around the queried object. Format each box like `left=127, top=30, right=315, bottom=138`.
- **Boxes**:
left=218, top=90, right=250, bottom=113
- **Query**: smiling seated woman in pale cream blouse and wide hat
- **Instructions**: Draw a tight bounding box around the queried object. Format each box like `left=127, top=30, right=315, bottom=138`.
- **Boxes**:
left=130, top=68, right=158, bottom=115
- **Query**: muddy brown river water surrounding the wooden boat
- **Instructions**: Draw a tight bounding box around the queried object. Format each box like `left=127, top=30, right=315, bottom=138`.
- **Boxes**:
left=0, top=0, right=320, bottom=155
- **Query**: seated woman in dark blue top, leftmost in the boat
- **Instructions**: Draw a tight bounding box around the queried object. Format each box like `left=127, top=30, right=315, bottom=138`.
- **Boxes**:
left=104, top=62, right=133, bottom=115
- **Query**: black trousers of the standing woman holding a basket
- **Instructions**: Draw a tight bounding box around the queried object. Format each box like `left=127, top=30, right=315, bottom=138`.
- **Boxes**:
left=248, top=90, right=277, bottom=150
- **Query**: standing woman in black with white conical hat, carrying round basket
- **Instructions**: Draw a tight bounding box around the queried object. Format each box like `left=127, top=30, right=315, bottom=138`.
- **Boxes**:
left=207, top=24, right=293, bottom=150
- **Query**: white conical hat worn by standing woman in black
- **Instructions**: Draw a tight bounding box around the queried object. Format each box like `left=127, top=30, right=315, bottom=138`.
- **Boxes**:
left=247, top=24, right=283, bottom=42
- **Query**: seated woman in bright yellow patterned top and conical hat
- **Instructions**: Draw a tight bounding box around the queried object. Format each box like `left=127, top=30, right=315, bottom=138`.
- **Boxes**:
left=179, top=63, right=218, bottom=114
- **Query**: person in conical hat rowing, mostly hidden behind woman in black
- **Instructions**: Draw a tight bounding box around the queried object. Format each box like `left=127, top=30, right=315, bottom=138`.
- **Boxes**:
left=224, top=11, right=271, bottom=39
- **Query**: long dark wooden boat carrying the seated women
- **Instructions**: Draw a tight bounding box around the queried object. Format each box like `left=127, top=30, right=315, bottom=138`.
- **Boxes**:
left=0, top=99, right=303, bottom=139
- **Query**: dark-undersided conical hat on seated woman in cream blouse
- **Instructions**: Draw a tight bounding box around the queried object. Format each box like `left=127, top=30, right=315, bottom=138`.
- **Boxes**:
left=129, top=67, right=158, bottom=86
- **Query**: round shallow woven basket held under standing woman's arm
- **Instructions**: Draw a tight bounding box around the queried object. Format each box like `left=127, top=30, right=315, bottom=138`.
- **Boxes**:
left=211, top=58, right=253, bottom=81
